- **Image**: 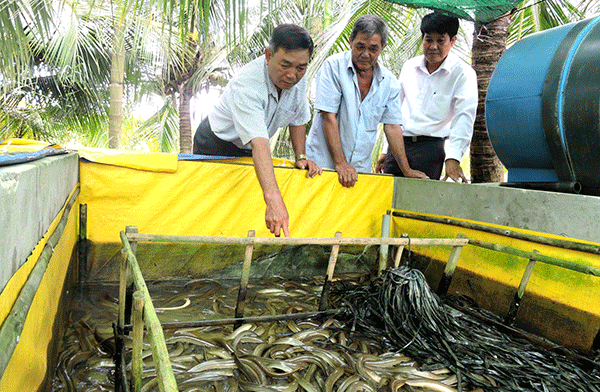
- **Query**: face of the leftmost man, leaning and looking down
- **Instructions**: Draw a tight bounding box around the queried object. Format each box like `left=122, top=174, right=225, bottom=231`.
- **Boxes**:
left=265, top=48, right=310, bottom=90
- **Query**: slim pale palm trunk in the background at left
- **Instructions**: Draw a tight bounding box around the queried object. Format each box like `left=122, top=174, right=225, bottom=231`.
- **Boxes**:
left=108, top=24, right=125, bottom=148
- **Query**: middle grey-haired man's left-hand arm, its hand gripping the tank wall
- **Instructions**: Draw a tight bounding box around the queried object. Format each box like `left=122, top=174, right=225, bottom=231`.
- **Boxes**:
left=319, top=111, right=358, bottom=188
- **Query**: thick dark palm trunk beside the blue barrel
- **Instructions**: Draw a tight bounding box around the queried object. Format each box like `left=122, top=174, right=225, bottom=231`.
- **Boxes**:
left=471, top=14, right=510, bottom=183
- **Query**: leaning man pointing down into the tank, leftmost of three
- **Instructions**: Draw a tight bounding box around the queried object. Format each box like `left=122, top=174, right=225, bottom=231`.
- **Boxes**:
left=193, top=24, right=322, bottom=237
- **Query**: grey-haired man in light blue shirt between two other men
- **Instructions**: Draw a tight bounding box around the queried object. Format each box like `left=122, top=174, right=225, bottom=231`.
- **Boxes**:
left=306, top=15, right=426, bottom=187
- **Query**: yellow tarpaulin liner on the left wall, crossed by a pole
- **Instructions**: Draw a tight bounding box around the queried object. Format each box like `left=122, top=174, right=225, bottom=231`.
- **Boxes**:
left=0, top=186, right=78, bottom=392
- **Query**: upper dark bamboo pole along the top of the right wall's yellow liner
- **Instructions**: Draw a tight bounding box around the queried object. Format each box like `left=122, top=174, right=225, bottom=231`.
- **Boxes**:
left=392, top=211, right=600, bottom=254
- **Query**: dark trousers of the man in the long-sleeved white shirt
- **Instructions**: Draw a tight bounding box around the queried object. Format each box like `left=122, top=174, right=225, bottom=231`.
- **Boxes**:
left=383, top=136, right=446, bottom=180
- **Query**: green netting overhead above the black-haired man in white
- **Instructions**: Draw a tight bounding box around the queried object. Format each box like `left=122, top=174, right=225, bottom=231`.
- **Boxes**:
left=387, top=0, right=521, bottom=23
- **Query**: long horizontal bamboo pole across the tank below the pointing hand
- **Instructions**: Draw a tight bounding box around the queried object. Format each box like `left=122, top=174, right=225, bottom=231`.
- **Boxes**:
left=127, top=234, right=469, bottom=246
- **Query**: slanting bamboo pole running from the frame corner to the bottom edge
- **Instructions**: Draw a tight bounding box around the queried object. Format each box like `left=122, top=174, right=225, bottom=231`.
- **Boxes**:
left=121, top=231, right=177, bottom=392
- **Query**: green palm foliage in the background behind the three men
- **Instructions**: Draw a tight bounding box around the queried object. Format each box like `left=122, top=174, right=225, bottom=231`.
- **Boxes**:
left=0, top=0, right=600, bottom=152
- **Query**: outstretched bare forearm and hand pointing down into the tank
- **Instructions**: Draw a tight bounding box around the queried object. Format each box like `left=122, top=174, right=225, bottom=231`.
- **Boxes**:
left=250, top=137, right=290, bottom=237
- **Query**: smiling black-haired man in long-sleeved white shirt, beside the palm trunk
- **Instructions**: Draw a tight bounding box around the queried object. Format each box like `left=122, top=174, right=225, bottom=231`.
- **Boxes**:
left=377, top=12, right=477, bottom=182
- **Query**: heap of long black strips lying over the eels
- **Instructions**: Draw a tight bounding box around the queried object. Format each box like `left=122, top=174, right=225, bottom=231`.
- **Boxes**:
left=334, top=267, right=600, bottom=392
